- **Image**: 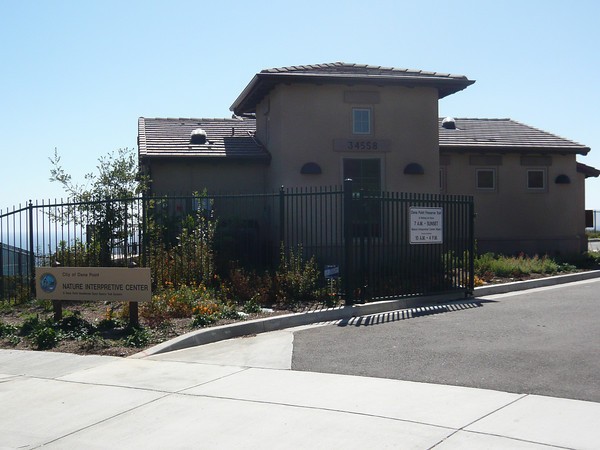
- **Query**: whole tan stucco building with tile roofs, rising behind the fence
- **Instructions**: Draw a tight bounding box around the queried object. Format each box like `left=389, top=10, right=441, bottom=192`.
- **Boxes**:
left=138, top=63, right=600, bottom=253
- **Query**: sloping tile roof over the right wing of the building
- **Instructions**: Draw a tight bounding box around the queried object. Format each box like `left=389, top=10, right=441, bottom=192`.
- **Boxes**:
left=440, top=118, right=590, bottom=155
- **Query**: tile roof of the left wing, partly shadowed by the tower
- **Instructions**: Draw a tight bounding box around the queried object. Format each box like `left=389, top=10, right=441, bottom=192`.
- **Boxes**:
left=138, top=117, right=270, bottom=161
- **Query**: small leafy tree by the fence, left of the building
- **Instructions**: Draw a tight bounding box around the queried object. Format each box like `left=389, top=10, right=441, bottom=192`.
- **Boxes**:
left=49, top=148, right=147, bottom=266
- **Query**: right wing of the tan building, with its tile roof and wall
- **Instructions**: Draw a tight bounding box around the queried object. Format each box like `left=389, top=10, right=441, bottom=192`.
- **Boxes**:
left=440, top=119, right=599, bottom=254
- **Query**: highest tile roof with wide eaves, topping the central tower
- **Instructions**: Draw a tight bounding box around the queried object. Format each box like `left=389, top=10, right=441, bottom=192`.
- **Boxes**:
left=230, top=62, right=475, bottom=115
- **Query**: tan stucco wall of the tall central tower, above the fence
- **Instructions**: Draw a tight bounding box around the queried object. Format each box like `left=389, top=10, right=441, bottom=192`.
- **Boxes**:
left=257, top=84, right=439, bottom=193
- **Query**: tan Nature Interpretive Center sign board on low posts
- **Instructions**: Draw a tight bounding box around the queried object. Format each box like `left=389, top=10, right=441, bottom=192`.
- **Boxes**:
left=36, top=267, right=152, bottom=302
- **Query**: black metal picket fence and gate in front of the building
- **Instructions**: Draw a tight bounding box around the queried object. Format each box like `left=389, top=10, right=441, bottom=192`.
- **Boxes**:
left=0, top=180, right=474, bottom=302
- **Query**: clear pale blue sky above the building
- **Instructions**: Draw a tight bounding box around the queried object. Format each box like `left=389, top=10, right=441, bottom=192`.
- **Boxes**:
left=0, top=0, right=600, bottom=211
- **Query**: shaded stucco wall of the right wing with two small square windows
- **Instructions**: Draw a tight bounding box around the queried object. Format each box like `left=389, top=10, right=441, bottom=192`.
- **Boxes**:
left=442, top=153, right=585, bottom=254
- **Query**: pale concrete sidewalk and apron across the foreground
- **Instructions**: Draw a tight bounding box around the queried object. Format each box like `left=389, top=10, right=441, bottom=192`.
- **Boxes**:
left=0, top=329, right=600, bottom=449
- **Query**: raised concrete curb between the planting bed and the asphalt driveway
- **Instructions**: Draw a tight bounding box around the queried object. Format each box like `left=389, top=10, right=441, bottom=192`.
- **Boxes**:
left=129, top=270, right=600, bottom=358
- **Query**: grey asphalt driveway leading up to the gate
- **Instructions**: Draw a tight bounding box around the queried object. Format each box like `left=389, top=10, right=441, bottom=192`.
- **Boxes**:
left=292, top=280, right=600, bottom=402
